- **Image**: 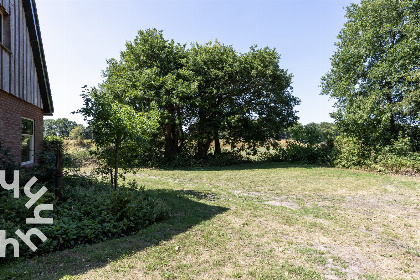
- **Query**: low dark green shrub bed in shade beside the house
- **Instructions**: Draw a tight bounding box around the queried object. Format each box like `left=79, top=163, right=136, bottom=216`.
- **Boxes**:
left=0, top=175, right=168, bottom=263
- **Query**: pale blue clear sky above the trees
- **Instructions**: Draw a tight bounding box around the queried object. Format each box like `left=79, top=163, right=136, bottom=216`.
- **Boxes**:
left=36, top=0, right=359, bottom=124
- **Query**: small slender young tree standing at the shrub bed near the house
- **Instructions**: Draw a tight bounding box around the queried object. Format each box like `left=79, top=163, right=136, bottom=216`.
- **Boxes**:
left=77, top=87, right=158, bottom=188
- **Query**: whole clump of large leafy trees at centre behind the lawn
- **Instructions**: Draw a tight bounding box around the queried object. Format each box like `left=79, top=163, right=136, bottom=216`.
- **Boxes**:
left=101, top=29, right=299, bottom=162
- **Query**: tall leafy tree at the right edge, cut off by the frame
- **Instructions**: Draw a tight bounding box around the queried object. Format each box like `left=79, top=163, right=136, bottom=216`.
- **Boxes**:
left=322, top=0, right=420, bottom=148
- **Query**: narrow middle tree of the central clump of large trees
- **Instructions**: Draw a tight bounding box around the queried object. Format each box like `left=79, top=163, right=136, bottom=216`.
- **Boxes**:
left=186, top=41, right=240, bottom=158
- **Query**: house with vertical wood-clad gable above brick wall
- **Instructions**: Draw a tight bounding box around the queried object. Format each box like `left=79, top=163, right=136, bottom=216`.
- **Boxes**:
left=0, top=0, right=54, bottom=166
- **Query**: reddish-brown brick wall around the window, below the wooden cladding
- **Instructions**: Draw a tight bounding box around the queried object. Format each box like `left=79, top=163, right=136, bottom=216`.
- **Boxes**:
left=0, top=90, right=44, bottom=165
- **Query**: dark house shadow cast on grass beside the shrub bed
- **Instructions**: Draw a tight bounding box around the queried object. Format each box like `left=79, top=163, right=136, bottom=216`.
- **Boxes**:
left=0, top=190, right=228, bottom=280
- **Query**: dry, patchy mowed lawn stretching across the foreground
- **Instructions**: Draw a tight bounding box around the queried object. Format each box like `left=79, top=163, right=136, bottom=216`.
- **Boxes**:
left=0, top=163, right=420, bottom=280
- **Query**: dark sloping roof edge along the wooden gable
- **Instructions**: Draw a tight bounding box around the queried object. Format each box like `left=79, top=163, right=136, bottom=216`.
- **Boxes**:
left=22, top=0, right=54, bottom=115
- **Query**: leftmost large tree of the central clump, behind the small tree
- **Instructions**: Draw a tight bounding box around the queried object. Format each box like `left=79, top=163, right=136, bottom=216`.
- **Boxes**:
left=101, top=29, right=195, bottom=160
